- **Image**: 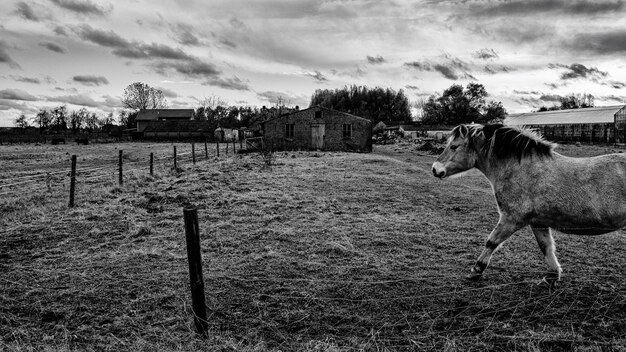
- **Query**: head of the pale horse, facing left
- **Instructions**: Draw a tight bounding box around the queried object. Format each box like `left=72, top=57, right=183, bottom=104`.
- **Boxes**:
left=433, top=125, right=484, bottom=178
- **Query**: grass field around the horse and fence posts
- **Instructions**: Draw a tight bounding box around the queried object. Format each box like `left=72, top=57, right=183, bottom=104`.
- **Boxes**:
left=0, top=143, right=626, bottom=351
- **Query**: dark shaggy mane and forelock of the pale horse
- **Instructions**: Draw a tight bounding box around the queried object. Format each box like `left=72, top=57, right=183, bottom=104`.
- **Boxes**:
left=452, top=124, right=556, bottom=161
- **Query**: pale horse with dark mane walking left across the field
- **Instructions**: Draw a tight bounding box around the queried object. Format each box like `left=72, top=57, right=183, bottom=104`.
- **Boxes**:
left=432, top=124, right=626, bottom=287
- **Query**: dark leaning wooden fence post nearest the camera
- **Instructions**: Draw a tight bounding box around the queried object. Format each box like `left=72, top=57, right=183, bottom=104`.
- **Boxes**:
left=183, top=206, right=209, bottom=335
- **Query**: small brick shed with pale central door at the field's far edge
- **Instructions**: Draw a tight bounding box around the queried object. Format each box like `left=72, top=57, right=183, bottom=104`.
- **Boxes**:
left=262, top=106, right=372, bottom=152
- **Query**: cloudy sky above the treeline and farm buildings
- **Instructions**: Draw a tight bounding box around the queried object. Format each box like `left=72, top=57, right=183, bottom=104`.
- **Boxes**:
left=0, top=0, right=626, bottom=126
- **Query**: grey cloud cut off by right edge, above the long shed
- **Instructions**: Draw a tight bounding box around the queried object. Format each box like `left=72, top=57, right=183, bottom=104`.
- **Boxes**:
left=564, top=28, right=626, bottom=55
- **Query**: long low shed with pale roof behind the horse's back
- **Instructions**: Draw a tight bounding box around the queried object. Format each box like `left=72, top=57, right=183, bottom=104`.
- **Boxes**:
left=504, top=105, right=626, bottom=143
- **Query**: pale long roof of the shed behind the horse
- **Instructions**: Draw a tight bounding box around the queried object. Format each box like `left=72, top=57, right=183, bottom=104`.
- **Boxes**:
left=504, top=105, right=624, bottom=126
